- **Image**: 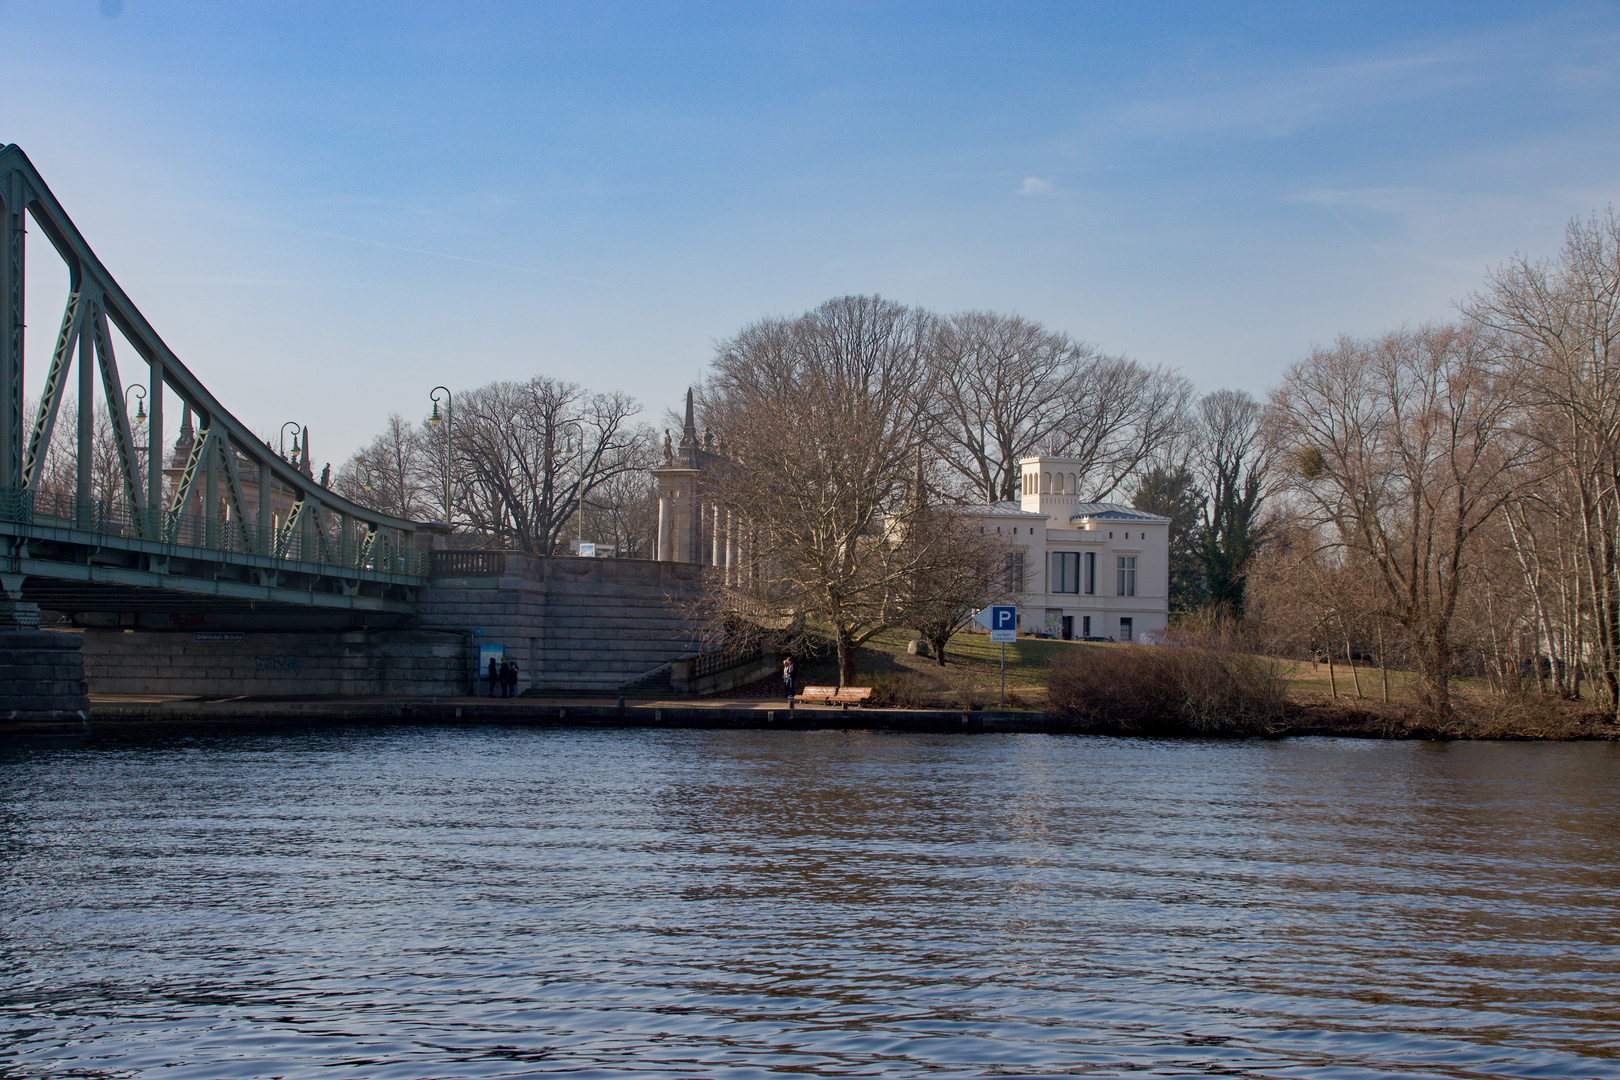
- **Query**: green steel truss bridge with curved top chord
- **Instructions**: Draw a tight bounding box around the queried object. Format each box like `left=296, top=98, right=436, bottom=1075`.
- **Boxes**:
left=0, top=146, right=428, bottom=628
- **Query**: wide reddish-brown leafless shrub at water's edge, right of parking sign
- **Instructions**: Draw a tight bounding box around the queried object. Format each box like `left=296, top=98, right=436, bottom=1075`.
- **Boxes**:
left=1047, top=635, right=1286, bottom=735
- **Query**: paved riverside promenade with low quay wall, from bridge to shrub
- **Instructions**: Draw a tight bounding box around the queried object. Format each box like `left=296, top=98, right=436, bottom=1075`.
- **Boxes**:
left=0, top=695, right=1072, bottom=735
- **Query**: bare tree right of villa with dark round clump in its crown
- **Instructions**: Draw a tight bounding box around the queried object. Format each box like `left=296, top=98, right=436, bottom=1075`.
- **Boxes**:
left=1270, top=325, right=1526, bottom=721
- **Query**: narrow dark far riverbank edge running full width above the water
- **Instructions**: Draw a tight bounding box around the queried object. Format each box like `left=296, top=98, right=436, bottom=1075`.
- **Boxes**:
left=0, top=698, right=1620, bottom=742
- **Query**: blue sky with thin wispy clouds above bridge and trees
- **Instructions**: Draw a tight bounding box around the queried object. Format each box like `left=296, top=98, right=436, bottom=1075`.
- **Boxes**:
left=0, top=0, right=1620, bottom=461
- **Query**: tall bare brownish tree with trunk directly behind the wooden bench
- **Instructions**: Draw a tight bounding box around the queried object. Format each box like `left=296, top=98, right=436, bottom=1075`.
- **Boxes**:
left=706, top=296, right=936, bottom=685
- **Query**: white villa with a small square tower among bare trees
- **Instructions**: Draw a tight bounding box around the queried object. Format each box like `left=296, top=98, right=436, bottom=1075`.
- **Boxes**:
left=975, top=457, right=1170, bottom=641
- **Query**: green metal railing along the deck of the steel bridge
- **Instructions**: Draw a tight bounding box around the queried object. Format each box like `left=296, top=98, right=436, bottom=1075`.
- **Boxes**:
left=0, top=487, right=430, bottom=576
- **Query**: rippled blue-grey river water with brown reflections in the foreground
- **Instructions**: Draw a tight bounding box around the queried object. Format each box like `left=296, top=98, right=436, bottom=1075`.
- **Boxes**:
left=0, top=729, right=1620, bottom=1080
